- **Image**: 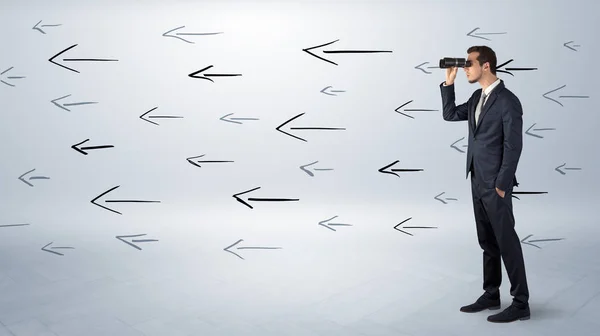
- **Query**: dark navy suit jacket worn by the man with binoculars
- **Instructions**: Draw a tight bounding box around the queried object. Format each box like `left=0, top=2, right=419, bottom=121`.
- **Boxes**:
left=440, top=80, right=523, bottom=191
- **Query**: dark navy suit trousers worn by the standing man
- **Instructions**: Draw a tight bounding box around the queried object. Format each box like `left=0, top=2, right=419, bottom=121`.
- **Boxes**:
left=471, top=171, right=529, bottom=307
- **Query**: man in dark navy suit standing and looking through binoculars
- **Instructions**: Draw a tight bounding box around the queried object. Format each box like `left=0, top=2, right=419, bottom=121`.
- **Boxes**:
left=440, top=46, right=530, bottom=322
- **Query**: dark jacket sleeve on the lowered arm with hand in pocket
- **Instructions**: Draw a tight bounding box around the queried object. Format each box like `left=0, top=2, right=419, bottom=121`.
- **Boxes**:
left=496, top=97, right=523, bottom=191
